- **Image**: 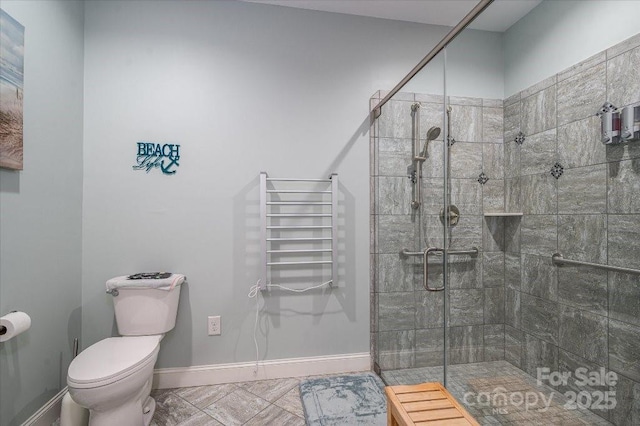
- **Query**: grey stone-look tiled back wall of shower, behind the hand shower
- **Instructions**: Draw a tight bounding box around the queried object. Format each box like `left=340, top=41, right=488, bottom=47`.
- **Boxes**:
left=371, top=93, right=505, bottom=370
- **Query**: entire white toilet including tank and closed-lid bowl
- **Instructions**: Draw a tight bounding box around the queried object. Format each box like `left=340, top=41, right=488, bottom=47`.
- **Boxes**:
left=67, top=274, right=185, bottom=426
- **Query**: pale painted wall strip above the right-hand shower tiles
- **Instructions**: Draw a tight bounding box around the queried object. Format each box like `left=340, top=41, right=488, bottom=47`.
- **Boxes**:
left=502, top=0, right=640, bottom=98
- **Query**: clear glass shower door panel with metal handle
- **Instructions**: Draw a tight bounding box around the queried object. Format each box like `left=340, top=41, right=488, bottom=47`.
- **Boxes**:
left=371, top=49, right=447, bottom=384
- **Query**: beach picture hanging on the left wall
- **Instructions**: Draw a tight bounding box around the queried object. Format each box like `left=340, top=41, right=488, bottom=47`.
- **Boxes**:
left=0, top=9, right=24, bottom=170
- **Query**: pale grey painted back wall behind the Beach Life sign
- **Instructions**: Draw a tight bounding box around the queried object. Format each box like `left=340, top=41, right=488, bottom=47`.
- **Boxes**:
left=82, top=1, right=502, bottom=367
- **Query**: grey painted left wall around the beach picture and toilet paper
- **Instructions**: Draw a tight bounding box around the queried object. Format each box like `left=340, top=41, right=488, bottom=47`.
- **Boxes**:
left=0, top=0, right=83, bottom=425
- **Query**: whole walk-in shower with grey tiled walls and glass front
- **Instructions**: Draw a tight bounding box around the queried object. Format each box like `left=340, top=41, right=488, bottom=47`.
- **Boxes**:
left=371, top=1, right=640, bottom=425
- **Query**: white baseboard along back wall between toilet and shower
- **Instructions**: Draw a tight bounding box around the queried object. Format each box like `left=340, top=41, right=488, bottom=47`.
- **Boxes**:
left=153, top=352, right=371, bottom=389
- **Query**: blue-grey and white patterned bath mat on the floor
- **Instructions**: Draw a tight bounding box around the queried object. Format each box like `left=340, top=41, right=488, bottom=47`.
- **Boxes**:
left=300, top=372, right=387, bottom=426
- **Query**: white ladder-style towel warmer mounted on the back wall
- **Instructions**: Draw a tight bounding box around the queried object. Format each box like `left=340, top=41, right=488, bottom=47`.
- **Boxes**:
left=259, top=172, right=338, bottom=290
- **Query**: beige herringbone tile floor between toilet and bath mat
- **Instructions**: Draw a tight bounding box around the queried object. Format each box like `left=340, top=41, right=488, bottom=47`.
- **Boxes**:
left=151, top=379, right=305, bottom=426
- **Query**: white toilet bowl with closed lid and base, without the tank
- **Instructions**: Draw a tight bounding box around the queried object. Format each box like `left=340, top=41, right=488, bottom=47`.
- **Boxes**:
left=67, top=335, right=162, bottom=426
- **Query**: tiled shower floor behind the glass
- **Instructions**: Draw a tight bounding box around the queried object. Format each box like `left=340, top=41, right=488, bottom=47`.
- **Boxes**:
left=382, top=361, right=611, bottom=426
